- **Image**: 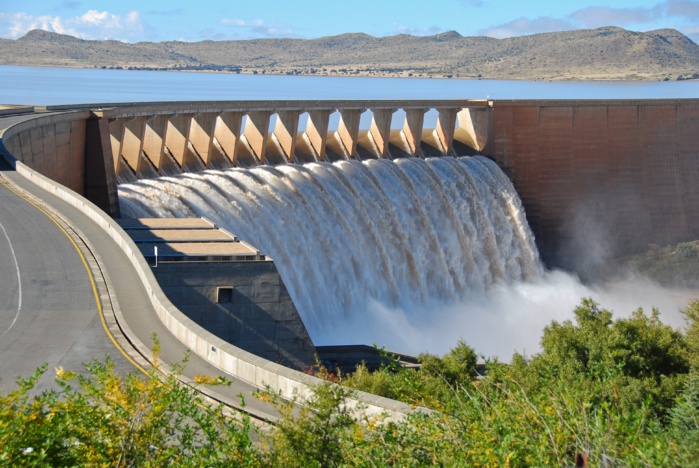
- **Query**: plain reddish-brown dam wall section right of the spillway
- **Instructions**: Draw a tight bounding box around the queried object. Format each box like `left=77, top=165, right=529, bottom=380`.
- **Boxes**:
left=483, top=99, right=699, bottom=274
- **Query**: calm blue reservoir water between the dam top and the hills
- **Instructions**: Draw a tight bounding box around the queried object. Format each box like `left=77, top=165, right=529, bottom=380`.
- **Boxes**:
left=0, top=66, right=699, bottom=105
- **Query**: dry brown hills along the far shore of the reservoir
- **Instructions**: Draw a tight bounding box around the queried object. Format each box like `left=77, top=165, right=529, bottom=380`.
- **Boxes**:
left=0, top=27, right=699, bottom=81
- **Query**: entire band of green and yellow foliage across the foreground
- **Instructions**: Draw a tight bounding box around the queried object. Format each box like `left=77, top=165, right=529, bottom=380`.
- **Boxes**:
left=0, top=300, right=699, bottom=467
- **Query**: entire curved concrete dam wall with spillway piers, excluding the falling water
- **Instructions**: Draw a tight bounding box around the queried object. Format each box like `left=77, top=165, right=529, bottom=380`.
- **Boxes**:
left=3, top=99, right=699, bottom=268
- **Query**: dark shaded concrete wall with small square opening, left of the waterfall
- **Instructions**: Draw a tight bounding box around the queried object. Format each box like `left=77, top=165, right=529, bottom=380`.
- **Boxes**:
left=152, top=261, right=315, bottom=370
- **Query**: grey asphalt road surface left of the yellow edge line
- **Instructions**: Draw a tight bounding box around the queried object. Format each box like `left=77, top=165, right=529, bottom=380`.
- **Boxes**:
left=0, top=156, right=133, bottom=392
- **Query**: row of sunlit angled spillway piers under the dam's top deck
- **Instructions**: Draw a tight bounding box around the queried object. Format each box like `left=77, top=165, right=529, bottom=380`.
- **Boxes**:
left=96, top=101, right=489, bottom=181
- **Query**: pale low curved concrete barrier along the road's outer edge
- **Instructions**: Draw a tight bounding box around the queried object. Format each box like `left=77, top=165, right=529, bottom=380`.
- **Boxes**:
left=3, top=111, right=414, bottom=419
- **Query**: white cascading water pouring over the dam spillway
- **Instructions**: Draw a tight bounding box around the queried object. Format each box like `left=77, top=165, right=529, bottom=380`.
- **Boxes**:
left=119, top=157, right=542, bottom=352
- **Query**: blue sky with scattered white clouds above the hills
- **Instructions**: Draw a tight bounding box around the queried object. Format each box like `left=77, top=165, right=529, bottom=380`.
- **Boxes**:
left=0, top=0, right=699, bottom=43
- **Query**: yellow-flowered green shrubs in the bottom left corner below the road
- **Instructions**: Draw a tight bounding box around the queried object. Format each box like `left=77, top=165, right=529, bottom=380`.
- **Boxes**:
left=0, top=346, right=257, bottom=467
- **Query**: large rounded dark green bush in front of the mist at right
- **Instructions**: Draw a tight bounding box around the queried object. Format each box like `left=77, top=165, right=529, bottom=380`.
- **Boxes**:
left=517, top=299, right=689, bottom=414
